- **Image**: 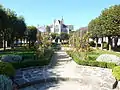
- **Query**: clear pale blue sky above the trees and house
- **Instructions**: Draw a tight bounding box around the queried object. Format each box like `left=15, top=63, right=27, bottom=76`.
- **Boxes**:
left=0, top=0, right=120, bottom=29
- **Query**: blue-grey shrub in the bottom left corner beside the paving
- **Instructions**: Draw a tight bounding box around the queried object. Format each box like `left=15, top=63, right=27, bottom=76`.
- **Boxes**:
left=0, top=75, right=13, bottom=90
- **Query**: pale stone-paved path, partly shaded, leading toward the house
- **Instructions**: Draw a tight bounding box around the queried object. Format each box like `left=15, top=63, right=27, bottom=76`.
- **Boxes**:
left=16, top=50, right=119, bottom=90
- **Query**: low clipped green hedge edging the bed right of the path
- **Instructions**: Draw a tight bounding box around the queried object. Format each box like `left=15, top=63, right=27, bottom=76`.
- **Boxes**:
left=67, top=51, right=117, bottom=69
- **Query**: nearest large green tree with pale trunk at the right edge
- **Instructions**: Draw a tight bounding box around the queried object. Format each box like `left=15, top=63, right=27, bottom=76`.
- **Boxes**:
left=101, top=5, right=120, bottom=50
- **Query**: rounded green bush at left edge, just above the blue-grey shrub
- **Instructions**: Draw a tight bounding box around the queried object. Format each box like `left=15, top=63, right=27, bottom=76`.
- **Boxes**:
left=0, top=62, right=15, bottom=77
